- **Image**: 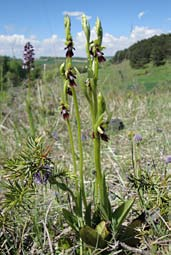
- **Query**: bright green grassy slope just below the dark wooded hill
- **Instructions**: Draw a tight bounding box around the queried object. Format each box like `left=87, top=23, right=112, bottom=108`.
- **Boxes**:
left=97, top=61, right=171, bottom=92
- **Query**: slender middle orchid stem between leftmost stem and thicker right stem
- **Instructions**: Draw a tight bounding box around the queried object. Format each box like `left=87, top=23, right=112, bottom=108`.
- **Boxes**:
left=71, top=87, right=87, bottom=208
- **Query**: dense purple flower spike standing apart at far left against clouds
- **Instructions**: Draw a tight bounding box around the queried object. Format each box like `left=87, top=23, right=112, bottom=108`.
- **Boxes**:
left=23, top=42, right=35, bottom=71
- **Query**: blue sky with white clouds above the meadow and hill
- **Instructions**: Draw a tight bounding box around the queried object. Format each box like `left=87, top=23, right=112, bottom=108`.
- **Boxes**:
left=0, top=0, right=171, bottom=56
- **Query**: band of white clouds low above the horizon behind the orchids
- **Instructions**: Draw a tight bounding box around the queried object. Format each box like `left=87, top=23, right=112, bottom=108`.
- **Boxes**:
left=0, top=26, right=162, bottom=58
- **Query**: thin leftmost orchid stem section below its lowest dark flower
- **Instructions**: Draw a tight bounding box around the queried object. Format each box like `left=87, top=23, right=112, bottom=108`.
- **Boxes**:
left=67, top=119, right=78, bottom=190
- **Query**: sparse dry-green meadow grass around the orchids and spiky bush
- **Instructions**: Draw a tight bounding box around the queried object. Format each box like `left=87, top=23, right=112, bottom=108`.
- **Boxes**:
left=0, top=62, right=171, bottom=255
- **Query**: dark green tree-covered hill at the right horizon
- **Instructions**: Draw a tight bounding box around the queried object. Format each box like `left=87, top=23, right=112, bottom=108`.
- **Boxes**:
left=111, top=33, right=171, bottom=68
